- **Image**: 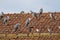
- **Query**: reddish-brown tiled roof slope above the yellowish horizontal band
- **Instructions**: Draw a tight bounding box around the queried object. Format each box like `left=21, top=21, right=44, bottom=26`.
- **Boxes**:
left=0, top=12, right=60, bottom=33
